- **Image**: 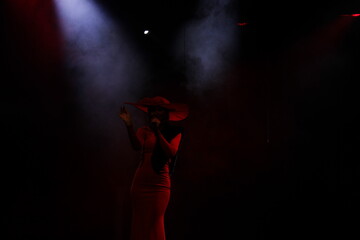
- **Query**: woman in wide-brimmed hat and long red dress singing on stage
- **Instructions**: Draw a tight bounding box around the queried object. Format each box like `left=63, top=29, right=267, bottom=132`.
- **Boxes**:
left=120, top=97, right=188, bottom=240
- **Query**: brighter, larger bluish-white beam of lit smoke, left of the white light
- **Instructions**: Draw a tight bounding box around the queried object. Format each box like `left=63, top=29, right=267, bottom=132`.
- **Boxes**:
left=55, top=0, right=146, bottom=133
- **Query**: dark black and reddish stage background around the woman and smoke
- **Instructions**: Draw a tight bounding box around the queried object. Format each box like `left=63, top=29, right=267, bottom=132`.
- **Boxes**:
left=1, top=0, right=360, bottom=240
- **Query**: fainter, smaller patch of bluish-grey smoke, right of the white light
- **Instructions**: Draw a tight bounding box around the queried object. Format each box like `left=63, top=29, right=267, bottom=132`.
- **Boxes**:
left=176, top=0, right=237, bottom=90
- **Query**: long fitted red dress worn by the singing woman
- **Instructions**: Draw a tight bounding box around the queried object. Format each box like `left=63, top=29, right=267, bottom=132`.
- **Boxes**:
left=131, top=127, right=181, bottom=240
